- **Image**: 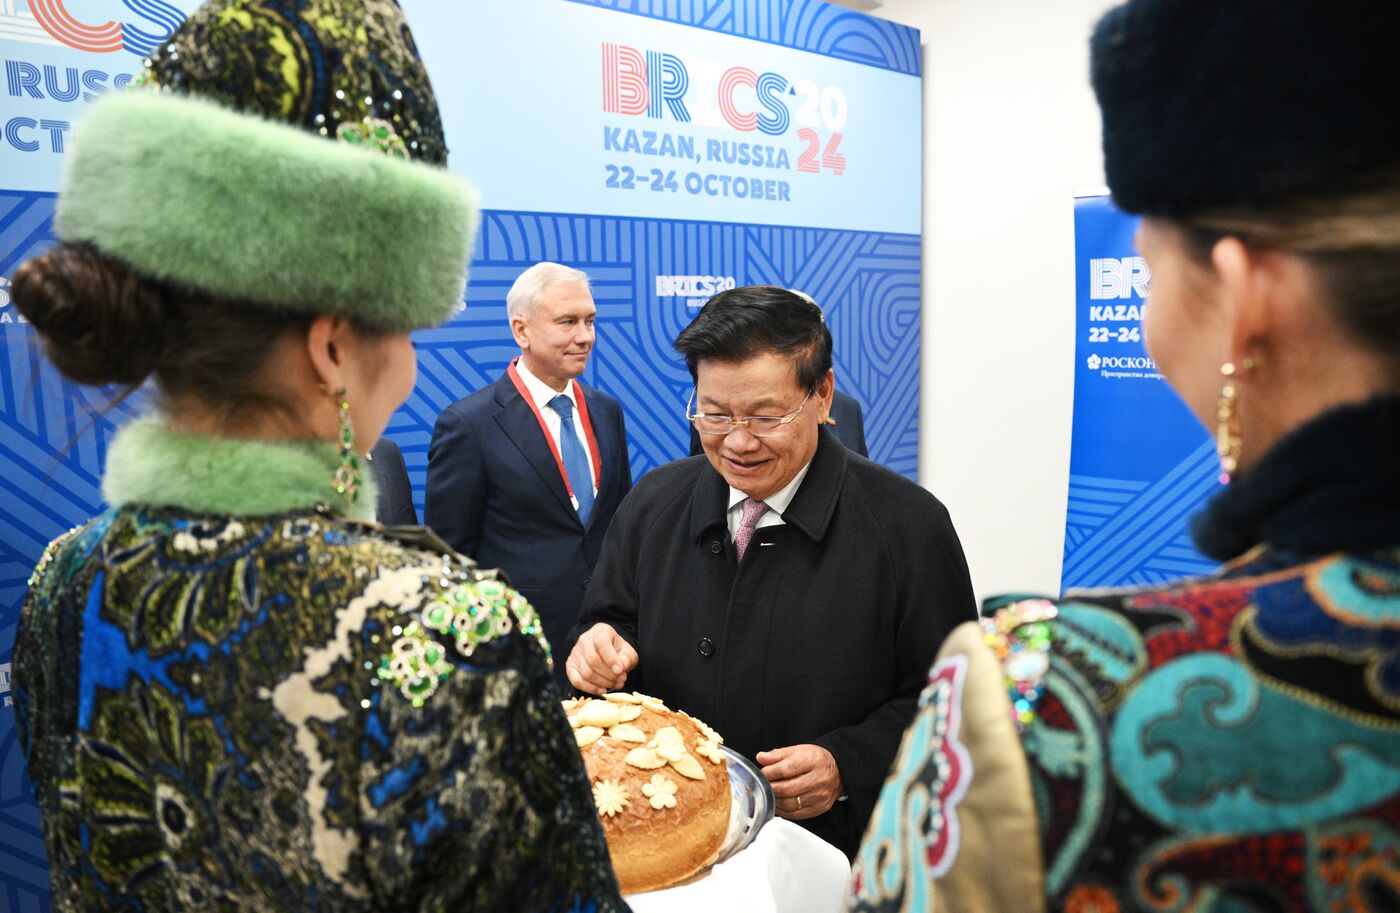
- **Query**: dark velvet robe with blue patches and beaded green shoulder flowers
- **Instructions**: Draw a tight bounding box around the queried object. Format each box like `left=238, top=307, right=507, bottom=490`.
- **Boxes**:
left=14, top=506, right=626, bottom=913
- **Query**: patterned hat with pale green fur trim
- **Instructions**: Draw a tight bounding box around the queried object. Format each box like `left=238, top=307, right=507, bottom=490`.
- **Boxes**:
left=55, top=0, right=479, bottom=330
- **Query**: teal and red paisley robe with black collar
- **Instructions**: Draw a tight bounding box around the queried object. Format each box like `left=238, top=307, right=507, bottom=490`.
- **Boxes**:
left=848, top=396, right=1400, bottom=913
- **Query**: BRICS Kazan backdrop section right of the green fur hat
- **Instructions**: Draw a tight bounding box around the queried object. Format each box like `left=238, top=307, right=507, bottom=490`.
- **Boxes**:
left=406, top=0, right=921, bottom=484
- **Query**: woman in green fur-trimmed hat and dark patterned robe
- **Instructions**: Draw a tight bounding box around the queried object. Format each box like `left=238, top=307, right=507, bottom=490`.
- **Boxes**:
left=13, top=0, right=626, bottom=912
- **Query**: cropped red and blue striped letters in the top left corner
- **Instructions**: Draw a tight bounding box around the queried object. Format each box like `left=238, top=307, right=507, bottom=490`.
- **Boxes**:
left=11, top=0, right=185, bottom=57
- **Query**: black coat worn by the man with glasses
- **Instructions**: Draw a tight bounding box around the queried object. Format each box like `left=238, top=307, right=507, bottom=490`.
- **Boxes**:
left=560, top=428, right=977, bottom=856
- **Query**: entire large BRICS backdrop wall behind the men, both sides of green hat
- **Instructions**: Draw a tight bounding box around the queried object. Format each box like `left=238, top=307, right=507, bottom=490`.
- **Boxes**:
left=0, top=0, right=921, bottom=912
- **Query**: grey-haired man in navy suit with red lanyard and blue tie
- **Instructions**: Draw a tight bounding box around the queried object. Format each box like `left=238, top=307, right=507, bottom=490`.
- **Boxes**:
left=423, top=262, right=631, bottom=685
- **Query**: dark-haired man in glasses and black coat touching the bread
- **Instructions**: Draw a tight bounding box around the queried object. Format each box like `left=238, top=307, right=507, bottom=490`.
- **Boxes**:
left=567, top=287, right=976, bottom=854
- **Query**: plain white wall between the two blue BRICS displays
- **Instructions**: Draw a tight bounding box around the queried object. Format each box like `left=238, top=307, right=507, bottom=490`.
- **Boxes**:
left=874, top=0, right=1114, bottom=597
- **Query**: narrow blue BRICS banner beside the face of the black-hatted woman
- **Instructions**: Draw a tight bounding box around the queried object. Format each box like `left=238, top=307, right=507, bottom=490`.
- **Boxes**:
left=1060, top=196, right=1221, bottom=590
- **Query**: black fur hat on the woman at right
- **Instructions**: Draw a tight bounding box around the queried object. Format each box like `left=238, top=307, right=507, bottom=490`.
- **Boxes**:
left=1089, top=0, right=1400, bottom=217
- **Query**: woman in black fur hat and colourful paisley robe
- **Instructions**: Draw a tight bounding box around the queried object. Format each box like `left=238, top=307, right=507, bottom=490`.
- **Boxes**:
left=850, top=0, right=1400, bottom=913
